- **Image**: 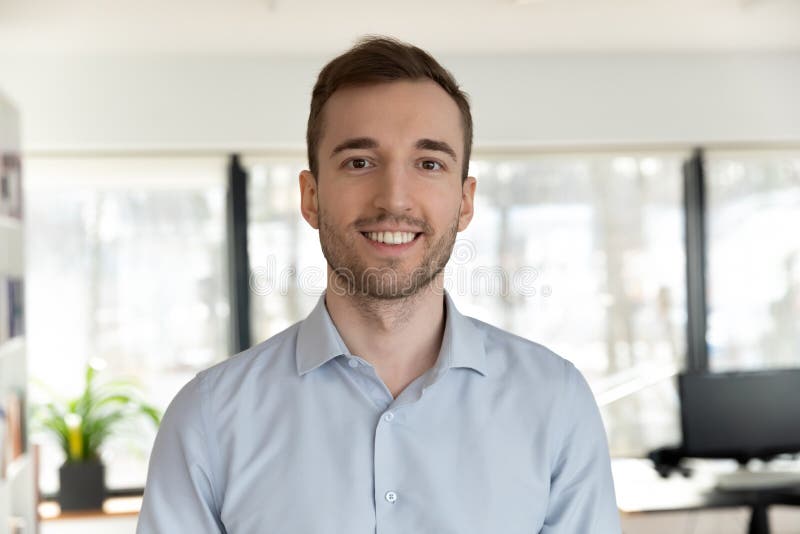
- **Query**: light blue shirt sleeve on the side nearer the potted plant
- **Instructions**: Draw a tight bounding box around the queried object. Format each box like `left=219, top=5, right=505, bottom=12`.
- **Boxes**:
left=136, top=375, right=225, bottom=534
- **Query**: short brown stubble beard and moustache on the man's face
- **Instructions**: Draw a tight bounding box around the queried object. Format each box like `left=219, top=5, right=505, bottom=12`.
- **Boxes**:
left=318, top=209, right=458, bottom=302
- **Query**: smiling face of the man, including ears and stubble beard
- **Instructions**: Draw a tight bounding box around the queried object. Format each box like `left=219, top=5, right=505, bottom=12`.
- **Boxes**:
left=300, top=81, right=475, bottom=299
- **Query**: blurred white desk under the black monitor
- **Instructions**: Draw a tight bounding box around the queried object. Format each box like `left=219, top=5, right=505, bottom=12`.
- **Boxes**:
left=612, top=459, right=800, bottom=534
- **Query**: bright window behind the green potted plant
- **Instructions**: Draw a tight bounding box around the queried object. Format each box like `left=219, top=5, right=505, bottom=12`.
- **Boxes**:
left=25, top=157, right=229, bottom=493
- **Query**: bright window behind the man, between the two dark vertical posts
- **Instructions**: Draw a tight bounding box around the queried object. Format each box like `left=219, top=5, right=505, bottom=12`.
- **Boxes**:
left=247, top=153, right=686, bottom=455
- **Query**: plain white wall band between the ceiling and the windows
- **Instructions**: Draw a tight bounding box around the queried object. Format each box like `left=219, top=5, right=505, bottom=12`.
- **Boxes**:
left=0, top=52, right=800, bottom=150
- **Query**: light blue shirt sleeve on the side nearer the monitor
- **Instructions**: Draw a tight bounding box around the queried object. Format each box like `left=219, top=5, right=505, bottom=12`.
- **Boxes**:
left=540, top=362, right=621, bottom=534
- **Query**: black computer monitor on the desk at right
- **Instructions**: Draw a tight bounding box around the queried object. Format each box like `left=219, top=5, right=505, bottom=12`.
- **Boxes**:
left=678, top=369, right=800, bottom=463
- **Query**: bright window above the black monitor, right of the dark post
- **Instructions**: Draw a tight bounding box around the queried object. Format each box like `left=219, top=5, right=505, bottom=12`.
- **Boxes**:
left=706, top=151, right=800, bottom=371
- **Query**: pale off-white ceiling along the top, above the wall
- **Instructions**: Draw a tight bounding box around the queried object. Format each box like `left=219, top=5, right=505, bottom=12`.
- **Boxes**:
left=0, top=0, right=800, bottom=55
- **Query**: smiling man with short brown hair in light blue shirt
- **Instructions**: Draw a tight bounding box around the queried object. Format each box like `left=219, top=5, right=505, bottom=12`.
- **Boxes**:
left=138, top=38, right=620, bottom=534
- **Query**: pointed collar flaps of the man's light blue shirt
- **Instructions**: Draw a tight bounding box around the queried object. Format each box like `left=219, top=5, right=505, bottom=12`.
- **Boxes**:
left=295, top=292, right=488, bottom=376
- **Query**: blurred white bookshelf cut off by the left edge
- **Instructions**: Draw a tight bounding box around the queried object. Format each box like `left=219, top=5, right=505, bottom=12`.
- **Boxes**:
left=0, top=95, right=37, bottom=534
